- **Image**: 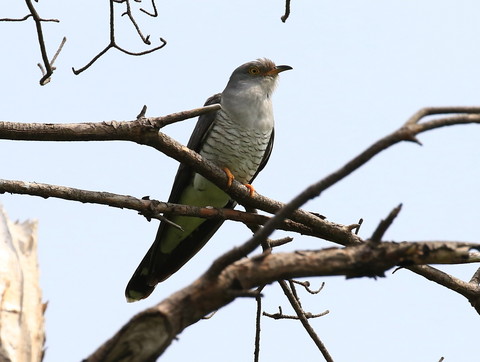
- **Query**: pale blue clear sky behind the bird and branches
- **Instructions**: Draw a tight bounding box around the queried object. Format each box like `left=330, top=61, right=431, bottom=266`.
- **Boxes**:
left=0, top=0, right=480, bottom=362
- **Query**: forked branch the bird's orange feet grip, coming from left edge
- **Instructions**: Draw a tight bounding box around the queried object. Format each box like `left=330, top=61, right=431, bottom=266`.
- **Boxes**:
left=0, top=105, right=361, bottom=245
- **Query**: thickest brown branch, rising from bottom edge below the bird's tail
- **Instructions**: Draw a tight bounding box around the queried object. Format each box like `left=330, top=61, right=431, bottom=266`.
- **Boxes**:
left=86, top=242, right=479, bottom=362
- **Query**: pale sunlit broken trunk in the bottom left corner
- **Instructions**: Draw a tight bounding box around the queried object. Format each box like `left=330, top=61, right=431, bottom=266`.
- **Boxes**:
left=0, top=205, right=45, bottom=362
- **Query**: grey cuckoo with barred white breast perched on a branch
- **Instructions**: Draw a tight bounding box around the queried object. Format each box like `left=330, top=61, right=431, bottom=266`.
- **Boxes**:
left=125, top=58, right=292, bottom=302
